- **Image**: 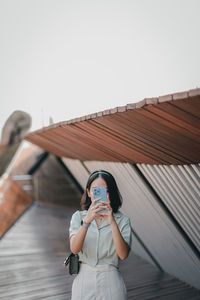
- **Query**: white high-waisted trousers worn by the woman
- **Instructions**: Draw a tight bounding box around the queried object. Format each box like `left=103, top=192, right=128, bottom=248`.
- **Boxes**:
left=71, top=264, right=127, bottom=300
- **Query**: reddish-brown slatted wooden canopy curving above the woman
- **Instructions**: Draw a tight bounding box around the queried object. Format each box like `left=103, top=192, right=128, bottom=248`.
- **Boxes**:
left=26, top=89, right=200, bottom=164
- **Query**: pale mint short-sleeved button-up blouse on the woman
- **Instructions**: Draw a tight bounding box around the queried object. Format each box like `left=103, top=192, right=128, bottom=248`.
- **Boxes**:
left=69, top=210, right=132, bottom=267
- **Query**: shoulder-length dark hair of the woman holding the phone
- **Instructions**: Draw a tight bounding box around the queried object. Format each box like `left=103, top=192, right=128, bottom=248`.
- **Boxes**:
left=80, top=170, right=122, bottom=213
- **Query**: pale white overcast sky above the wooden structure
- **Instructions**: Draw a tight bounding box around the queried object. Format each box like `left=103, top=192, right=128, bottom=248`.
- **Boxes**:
left=0, top=0, right=200, bottom=139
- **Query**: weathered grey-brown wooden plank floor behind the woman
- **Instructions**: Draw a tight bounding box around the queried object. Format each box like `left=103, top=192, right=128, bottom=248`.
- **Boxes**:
left=0, top=203, right=200, bottom=300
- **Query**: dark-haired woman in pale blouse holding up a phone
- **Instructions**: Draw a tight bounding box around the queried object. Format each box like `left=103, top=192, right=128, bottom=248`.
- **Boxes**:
left=69, top=170, right=131, bottom=300
